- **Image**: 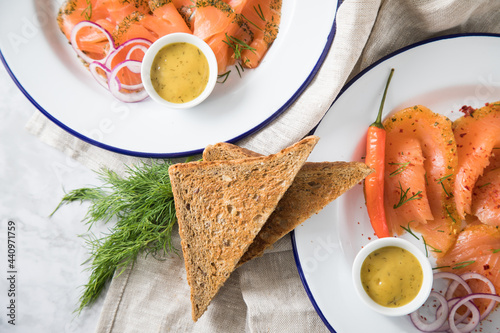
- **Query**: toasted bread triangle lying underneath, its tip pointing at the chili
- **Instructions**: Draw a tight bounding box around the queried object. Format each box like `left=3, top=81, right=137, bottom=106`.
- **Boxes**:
left=203, top=143, right=373, bottom=266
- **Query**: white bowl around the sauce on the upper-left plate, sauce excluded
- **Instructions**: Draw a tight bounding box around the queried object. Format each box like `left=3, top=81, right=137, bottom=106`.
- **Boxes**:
left=141, top=32, right=218, bottom=108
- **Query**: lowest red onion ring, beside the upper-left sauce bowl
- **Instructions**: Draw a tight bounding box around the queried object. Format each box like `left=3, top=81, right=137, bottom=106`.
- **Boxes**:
left=108, top=60, right=148, bottom=103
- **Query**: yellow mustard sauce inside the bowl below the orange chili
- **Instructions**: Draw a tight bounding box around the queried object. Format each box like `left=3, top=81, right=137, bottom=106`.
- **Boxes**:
left=361, top=246, right=424, bottom=308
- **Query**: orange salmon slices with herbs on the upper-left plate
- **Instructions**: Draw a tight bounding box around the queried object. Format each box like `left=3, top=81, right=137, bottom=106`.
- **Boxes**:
left=57, top=0, right=282, bottom=74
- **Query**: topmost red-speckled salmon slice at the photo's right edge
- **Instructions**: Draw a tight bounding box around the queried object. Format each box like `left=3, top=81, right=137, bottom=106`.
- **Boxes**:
left=453, top=102, right=500, bottom=218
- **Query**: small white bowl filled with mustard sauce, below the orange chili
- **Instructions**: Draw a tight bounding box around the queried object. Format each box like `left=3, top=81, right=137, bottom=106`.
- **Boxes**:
left=352, top=237, right=433, bottom=316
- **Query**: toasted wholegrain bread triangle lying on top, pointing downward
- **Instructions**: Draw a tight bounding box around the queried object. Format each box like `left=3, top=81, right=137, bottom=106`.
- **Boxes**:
left=169, top=136, right=318, bottom=321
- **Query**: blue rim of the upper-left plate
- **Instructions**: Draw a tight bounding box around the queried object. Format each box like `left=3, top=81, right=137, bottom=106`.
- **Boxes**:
left=0, top=0, right=343, bottom=159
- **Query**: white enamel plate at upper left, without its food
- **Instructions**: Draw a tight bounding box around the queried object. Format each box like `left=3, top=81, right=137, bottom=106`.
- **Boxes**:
left=0, top=0, right=337, bottom=157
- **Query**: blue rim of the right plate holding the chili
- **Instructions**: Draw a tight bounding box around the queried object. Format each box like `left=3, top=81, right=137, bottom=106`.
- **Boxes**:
left=290, top=32, right=500, bottom=333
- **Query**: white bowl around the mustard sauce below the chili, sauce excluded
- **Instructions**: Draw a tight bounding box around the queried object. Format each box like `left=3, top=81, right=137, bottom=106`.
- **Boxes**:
left=352, top=237, right=433, bottom=316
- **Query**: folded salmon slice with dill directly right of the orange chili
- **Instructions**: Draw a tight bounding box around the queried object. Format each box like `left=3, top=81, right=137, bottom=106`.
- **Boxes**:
left=384, top=105, right=459, bottom=256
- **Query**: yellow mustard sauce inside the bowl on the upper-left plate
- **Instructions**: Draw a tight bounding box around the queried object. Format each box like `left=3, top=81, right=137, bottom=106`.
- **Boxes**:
left=151, top=43, right=210, bottom=103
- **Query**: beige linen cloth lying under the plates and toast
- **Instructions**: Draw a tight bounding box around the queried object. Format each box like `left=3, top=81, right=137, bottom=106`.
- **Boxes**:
left=27, top=0, right=500, bottom=333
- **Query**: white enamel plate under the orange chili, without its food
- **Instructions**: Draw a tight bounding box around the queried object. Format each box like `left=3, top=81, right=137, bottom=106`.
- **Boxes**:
left=292, top=35, right=500, bottom=333
